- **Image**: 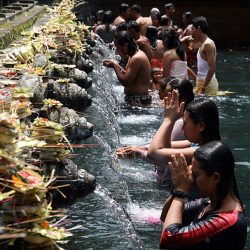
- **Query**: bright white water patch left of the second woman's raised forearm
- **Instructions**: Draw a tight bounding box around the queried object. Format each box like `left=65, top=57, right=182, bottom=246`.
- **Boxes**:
left=118, top=115, right=158, bottom=125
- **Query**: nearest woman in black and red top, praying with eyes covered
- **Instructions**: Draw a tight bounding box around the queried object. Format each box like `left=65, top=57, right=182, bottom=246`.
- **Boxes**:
left=160, top=141, right=247, bottom=250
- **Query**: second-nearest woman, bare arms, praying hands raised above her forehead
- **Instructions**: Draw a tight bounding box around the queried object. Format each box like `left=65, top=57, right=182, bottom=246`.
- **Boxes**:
left=147, top=91, right=221, bottom=164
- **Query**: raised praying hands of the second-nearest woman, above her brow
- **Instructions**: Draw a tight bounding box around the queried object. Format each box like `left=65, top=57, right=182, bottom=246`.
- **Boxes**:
left=164, top=90, right=184, bottom=121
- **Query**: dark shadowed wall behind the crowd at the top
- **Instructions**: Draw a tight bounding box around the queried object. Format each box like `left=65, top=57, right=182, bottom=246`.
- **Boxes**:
left=89, top=0, right=250, bottom=48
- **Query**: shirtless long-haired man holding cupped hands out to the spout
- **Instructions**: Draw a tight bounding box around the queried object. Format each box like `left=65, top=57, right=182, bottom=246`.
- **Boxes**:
left=103, top=31, right=152, bottom=105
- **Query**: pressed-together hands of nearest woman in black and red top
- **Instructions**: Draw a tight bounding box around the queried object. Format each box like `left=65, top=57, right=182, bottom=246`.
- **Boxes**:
left=169, top=153, right=194, bottom=193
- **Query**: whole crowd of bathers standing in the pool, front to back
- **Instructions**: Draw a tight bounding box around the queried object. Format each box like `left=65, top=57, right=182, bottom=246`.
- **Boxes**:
left=93, top=3, right=247, bottom=250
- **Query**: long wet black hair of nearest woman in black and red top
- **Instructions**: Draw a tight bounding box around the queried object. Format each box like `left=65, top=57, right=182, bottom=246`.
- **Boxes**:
left=194, top=141, right=243, bottom=210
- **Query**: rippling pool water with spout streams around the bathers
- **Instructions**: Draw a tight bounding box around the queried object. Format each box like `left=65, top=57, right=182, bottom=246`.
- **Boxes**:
left=65, top=45, right=250, bottom=250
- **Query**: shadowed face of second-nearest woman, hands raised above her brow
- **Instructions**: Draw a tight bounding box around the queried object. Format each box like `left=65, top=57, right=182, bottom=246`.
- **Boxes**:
left=182, top=111, right=204, bottom=143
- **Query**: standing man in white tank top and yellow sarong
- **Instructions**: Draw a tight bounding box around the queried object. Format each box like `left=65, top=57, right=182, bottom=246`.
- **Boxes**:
left=192, top=16, right=218, bottom=95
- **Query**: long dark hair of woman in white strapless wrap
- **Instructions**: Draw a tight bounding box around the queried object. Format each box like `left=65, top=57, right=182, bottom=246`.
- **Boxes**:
left=162, top=28, right=185, bottom=61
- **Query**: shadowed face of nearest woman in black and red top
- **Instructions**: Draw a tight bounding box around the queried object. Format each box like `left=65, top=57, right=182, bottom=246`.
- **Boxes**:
left=192, top=158, right=218, bottom=197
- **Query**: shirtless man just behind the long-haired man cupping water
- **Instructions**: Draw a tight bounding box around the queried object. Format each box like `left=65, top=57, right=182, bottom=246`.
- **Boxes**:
left=127, top=21, right=152, bottom=62
